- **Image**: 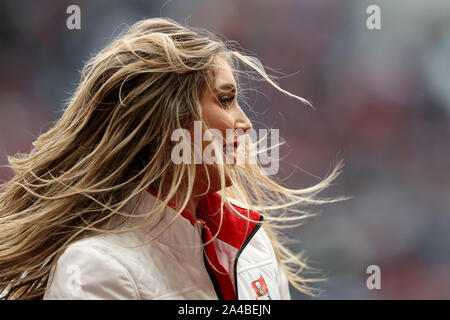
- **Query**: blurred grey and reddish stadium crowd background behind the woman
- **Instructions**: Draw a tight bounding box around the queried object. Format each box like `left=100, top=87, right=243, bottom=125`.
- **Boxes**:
left=0, top=0, right=450, bottom=299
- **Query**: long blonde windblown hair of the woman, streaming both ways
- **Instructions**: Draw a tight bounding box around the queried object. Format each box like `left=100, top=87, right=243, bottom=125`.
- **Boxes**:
left=0, top=18, right=342, bottom=299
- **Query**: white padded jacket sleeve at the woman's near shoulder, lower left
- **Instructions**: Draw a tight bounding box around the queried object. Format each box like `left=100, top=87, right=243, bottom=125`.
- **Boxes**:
left=44, top=245, right=139, bottom=300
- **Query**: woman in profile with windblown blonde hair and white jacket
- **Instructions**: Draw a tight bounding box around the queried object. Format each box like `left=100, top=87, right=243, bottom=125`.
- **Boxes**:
left=0, top=18, right=340, bottom=299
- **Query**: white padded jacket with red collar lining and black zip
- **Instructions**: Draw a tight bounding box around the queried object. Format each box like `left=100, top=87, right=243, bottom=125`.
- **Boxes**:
left=44, top=192, right=290, bottom=300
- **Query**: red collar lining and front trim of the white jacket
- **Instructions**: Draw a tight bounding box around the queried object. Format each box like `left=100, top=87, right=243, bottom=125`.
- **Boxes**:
left=148, top=189, right=261, bottom=300
